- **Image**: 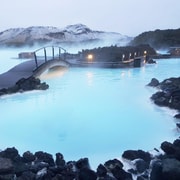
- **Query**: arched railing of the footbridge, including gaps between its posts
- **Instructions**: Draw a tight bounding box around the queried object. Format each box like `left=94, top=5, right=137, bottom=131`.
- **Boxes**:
left=34, top=46, right=66, bottom=68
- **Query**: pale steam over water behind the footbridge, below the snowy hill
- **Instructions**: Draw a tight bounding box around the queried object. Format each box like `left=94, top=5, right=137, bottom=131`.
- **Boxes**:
left=0, top=39, right=129, bottom=73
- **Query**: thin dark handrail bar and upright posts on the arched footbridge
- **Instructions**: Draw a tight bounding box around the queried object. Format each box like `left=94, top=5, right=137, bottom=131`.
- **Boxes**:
left=33, top=46, right=66, bottom=69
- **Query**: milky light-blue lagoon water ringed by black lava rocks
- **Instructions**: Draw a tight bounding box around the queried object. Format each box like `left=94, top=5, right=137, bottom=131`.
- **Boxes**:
left=0, top=48, right=180, bottom=168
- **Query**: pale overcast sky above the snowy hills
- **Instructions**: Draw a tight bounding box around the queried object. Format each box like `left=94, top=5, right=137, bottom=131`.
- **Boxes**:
left=0, top=0, right=180, bottom=36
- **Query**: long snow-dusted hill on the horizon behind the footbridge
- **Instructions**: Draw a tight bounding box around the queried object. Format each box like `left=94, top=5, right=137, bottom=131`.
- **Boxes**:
left=0, top=24, right=132, bottom=46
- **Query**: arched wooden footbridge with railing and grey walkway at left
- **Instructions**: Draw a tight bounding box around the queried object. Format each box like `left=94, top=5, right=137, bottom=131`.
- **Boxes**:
left=0, top=46, right=70, bottom=89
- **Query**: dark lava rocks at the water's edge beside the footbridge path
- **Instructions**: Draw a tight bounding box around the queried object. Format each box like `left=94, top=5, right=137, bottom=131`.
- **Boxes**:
left=0, top=76, right=49, bottom=96
